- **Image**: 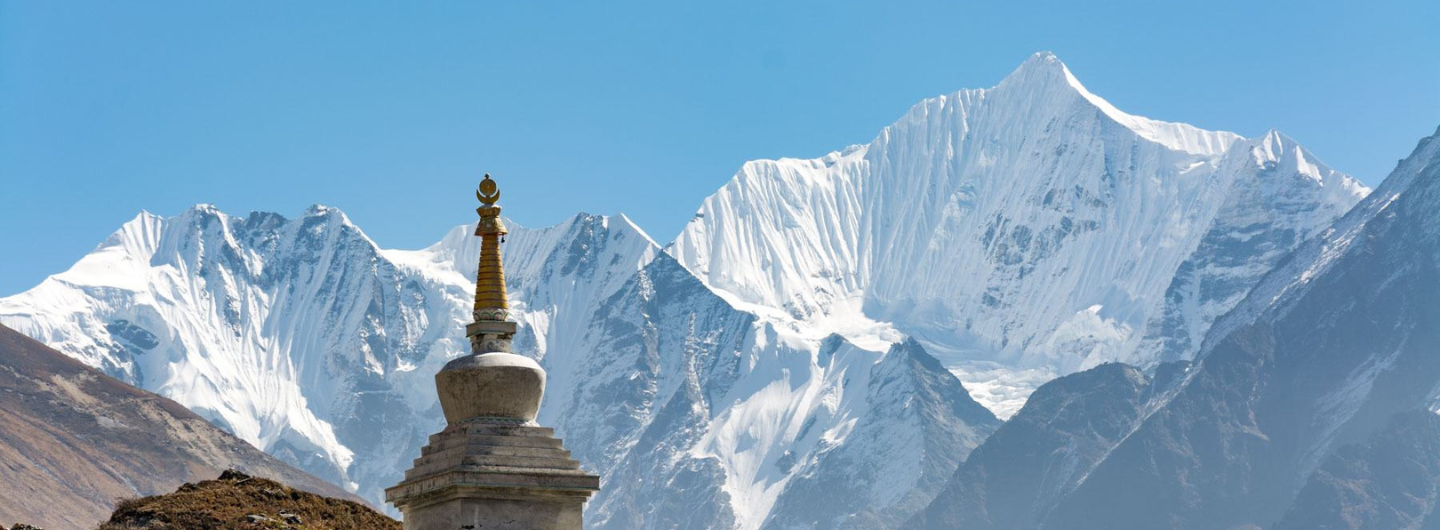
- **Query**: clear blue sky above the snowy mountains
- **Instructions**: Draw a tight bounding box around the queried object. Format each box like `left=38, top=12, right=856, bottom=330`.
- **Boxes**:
left=0, top=0, right=1440, bottom=295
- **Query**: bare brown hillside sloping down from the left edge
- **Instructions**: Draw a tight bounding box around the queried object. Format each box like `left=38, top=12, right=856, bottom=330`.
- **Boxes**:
left=0, top=325, right=359, bottom=530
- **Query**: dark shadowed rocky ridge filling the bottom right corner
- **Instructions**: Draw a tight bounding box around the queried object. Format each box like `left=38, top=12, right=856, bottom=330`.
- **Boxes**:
left=1274, top=410, right=1440, bottom=530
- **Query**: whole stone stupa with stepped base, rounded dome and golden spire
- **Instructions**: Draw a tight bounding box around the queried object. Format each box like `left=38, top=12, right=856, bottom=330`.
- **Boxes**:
left=384, top=174, right=600, bottom=530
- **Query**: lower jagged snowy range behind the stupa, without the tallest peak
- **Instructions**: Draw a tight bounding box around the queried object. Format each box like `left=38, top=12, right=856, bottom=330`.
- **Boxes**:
left=0, top=206, right=998, bottom=529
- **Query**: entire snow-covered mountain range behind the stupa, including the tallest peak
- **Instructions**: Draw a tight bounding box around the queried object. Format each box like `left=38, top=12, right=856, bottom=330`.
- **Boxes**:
left=0, top=53, right=1368, bottom=530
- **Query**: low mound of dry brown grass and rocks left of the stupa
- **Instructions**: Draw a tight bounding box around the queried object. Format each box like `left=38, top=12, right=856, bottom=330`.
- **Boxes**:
left=99, top=471, right=400, bottom=530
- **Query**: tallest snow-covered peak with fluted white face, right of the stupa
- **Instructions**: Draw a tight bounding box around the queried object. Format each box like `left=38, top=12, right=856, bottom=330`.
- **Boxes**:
left=668, top=53, right=1368, bottom=416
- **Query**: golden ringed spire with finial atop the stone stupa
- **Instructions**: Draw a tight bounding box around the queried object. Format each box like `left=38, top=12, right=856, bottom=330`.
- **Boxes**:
left=465, top=173, right=516, bottom=354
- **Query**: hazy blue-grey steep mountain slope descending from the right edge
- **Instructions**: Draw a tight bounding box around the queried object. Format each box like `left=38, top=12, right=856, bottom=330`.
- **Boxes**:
left=1045, top=126, right=1440, bottom=529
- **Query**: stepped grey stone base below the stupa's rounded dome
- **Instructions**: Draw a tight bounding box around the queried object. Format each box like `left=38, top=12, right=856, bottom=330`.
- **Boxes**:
left=384, top=419, right=600, bottom=530
